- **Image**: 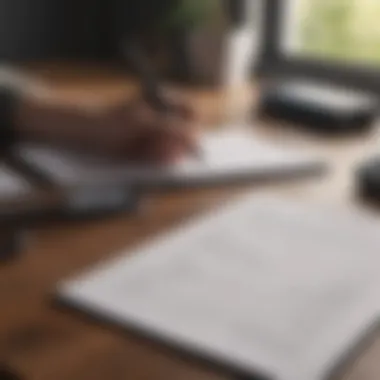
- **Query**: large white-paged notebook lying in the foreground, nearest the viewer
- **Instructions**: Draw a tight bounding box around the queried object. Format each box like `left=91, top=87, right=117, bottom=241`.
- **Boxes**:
left=56, top=195, right=380, bottom=380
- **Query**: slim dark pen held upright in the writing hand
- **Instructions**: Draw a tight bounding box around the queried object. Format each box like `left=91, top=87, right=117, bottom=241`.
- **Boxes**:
left=124, top=43, right=202, bottom=158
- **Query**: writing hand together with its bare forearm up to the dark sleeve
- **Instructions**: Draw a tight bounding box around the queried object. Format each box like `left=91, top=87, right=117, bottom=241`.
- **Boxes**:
left=18, top=93, right=197, bottom=164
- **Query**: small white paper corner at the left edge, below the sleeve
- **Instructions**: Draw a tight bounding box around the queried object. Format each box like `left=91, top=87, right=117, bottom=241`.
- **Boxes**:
left=0, top=164, right=31, bottom=200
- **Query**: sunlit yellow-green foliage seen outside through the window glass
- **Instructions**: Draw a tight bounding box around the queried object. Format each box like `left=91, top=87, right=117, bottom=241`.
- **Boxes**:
left=299, top=0, right=380, bottom=63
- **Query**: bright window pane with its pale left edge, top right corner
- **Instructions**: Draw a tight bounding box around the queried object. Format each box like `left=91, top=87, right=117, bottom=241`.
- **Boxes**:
left=279, top=0, right=380, bottom=69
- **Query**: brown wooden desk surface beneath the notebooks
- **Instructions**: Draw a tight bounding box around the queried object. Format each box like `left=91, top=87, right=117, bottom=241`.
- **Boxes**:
left=0, top=69, right=380, bottom=380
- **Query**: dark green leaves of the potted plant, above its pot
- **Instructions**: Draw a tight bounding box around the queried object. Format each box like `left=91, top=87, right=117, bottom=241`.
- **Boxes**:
left=163, top=0, right=220, bottom=30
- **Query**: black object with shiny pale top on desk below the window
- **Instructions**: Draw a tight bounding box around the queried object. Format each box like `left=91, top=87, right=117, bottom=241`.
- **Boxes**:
left=259, top=80, right=378, bottom=135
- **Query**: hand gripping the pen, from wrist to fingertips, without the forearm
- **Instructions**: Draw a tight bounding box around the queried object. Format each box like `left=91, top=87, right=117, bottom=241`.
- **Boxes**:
left=99, top=94, right=197, bottom=164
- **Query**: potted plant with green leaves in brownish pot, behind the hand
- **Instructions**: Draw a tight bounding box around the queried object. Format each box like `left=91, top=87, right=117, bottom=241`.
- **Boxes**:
left=161, top=0, right=226, bottom=85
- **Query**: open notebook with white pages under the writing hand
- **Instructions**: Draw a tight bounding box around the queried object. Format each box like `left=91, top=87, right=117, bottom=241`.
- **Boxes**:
left=15, top=131, right=324, bottom=186
